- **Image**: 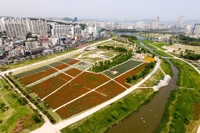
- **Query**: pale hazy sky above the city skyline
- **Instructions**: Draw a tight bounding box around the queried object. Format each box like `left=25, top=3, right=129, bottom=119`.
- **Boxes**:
left=0, top=0, right=200, bottom=21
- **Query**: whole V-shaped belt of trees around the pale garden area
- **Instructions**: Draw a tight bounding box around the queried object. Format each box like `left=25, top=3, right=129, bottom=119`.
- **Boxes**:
left=92, top=46, right=133, bottom=72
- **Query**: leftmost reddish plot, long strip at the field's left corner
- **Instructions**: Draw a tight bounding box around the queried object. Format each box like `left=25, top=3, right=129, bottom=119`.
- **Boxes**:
left=19, top=68, right=57, bottom=85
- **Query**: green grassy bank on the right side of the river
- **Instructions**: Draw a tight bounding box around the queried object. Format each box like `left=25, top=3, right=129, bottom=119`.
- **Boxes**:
left=156, top=59, right=200, bottom=133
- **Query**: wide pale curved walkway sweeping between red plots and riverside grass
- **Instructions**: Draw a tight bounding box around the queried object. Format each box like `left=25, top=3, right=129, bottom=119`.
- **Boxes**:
left=32, top=58, right=160, bottom=133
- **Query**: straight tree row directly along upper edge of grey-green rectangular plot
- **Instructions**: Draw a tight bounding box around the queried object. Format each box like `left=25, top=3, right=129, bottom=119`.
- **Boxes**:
left=92, top=50, right=133, bottom=72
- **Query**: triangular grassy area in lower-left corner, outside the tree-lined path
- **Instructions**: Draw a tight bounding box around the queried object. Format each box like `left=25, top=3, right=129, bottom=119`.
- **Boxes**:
left=0, top=78, right=43, bottom=133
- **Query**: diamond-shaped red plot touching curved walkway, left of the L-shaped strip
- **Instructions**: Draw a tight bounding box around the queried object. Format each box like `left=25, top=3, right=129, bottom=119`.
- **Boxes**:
left=96, top=81, right=125, bottom=98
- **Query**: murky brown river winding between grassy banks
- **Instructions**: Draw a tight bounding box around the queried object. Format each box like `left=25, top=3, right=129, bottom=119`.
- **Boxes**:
left=107, top=33, right=179, bottom=133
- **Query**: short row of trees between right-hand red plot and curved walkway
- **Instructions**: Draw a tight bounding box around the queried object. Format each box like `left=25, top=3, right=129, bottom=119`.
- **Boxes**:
left=126, top=62, right=156, bottom=83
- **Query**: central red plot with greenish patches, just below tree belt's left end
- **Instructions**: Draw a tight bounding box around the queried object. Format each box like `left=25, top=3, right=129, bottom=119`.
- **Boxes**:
left=72, top=72, right=109, bottom=89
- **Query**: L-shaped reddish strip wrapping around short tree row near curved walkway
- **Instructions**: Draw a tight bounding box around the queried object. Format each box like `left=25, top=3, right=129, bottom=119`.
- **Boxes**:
left=115, top=63, right=148, bottom=88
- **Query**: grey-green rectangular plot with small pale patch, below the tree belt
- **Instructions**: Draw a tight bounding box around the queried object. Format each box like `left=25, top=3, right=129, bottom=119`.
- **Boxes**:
left=104, top=60, right=142, bottom=78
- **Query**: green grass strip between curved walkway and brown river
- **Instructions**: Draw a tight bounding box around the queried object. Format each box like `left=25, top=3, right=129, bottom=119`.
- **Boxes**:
left=61, top=89, right=154, bottom=133
